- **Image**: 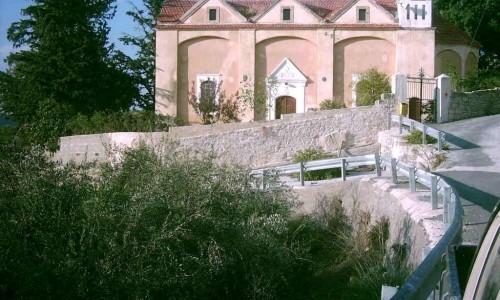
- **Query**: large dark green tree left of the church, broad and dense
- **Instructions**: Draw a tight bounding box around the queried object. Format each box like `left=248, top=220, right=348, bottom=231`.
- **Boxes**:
left=0, top=0, right=138, bottom=149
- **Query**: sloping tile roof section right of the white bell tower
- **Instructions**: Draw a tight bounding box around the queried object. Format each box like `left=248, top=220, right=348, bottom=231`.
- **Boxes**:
left=432, top=14, right=481, bottom=48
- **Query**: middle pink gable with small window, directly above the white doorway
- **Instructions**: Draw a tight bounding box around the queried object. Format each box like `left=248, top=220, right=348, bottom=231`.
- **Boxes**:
left=254, top=0, right=321, bottom=24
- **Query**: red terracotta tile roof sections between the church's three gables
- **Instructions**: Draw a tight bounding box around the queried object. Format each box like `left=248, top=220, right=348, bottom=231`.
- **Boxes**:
left=158, top=0, right=397, bottom=22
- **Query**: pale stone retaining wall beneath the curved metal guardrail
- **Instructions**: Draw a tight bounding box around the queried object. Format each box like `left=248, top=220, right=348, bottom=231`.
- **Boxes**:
left=294, top=177, right=444, bottom=268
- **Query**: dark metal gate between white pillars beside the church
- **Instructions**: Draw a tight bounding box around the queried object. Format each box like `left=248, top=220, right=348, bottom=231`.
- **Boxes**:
left=407, top=69, right=436, bottom=123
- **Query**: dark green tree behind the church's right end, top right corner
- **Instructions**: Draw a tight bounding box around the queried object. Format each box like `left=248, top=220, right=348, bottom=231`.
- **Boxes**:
left=435, top=0, right=500, bottom=69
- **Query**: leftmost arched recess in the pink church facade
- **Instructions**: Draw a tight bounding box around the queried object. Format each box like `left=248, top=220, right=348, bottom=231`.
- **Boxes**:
left=177, top=36, right=239, bottom=122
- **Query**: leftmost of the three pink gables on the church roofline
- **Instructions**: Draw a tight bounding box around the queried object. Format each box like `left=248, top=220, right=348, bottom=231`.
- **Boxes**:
left=181, top=0, right=246, bottom=24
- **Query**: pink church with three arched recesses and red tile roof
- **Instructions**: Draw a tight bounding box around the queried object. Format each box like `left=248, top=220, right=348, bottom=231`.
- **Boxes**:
left=156, top=0, right=480, bottom=123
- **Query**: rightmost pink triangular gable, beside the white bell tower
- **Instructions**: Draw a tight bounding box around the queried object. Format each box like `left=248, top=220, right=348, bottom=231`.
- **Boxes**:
left=332, top=0, right=396, bottom=24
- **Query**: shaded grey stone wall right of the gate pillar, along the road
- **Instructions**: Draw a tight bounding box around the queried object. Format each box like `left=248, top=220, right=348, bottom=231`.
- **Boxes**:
left=448, top=88, right=500, bottom=122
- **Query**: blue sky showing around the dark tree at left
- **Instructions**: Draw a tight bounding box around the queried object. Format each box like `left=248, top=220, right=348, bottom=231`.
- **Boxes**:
left=0, top=0, right=146, bottom=71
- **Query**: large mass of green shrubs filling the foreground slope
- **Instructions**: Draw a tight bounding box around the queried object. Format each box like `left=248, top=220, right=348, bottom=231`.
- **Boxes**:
left=0, top=145, right=410, bottom=299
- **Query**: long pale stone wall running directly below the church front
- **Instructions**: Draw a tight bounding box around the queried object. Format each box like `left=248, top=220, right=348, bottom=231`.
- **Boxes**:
left=54, top=107, right=387, bottom=167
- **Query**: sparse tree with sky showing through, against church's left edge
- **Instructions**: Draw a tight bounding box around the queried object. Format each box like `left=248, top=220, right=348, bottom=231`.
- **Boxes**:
left=120, top=0, right=165, bottom=110
